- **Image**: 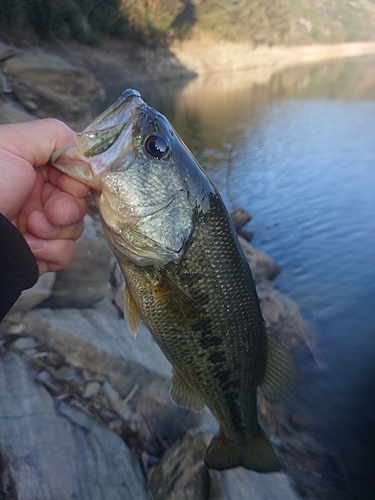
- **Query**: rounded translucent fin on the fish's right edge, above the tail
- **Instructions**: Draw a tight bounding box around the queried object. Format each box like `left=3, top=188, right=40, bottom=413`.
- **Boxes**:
left=259, top=335, right=297, bottom=404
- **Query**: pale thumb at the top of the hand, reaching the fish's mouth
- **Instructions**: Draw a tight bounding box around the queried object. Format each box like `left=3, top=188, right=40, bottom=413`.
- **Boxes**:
left=0, top=118, right=74, bottom=167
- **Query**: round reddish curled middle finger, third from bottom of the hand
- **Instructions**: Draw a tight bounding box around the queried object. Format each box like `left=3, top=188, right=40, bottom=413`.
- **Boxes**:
left=44, top=191, right=87, bottom=227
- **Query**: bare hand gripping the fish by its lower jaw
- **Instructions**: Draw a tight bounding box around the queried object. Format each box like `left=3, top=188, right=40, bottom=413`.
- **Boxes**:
left=0, top=118, right=89, bottom=275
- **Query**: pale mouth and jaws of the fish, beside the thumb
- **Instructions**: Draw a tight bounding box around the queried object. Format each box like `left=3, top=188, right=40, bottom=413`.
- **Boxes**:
left=50, top=89, right=145, bottom=191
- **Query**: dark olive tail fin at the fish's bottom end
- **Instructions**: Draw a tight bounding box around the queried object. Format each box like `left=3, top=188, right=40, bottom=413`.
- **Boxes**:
left=204, top=430, right=280, bottom=472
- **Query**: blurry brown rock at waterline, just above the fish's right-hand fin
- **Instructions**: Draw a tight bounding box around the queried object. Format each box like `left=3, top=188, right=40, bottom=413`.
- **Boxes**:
left=257, top=281, right=308, bottom=354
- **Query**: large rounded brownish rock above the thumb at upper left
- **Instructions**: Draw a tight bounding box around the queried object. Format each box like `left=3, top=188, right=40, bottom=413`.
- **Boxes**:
left=3, top=50, right=104, bottom=126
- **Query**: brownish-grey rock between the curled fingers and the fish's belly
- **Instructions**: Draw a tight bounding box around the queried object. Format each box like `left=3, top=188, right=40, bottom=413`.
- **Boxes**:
left=43, top=216, right=115, bottom=308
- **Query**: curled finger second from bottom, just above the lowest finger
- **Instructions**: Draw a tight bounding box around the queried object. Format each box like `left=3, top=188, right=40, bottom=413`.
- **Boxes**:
left=27, top=210, right=83, bottom=240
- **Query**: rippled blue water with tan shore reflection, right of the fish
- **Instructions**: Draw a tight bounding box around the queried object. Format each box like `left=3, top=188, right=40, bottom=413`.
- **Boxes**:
left=103, top=57, right=375, bottom=500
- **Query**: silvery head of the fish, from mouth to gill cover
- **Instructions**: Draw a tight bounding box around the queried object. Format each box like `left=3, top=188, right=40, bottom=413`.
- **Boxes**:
left=51, top=90, right=214, bottom=266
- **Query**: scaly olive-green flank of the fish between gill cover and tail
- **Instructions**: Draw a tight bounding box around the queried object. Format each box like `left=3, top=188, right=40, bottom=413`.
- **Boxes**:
left=120, top=192, right=266, bottom=440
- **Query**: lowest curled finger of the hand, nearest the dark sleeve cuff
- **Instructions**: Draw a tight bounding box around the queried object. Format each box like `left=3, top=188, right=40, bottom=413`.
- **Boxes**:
left=25, top=234, right=77, bottom=274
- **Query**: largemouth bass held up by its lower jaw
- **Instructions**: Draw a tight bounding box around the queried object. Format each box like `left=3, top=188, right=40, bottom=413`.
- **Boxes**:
left=51, top=89, right=296, bottom=472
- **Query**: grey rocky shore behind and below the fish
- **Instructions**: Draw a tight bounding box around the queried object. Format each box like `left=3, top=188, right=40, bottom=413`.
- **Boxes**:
left=0, top=40, right=352, bottom=500
